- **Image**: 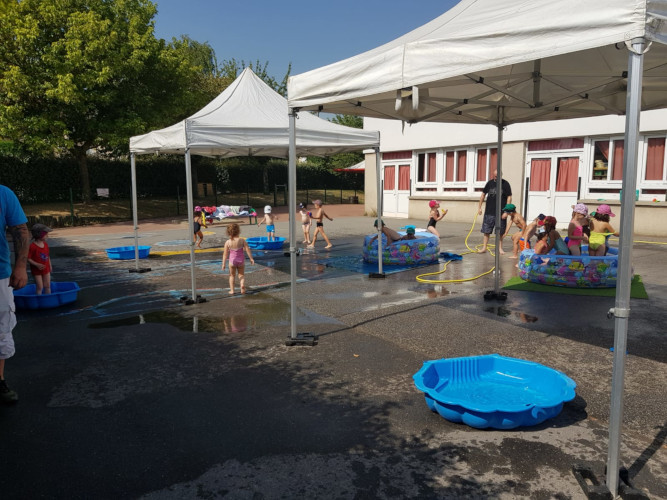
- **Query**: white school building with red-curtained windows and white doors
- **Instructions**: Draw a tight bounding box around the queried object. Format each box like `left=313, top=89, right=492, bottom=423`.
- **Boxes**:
left=364, top=110, right=667, bottom=236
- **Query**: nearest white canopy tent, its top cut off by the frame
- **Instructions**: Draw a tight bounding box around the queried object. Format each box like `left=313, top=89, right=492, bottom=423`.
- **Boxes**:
left=288, top=0, right=667, bottom=494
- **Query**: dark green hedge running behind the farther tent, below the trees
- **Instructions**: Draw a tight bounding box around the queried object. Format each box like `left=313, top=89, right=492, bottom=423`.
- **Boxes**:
left=0, top=150, right=363, bottom=203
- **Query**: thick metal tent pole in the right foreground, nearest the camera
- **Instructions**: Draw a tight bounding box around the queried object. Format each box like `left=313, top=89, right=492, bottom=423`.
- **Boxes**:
left=607, top=38, right=645, bottom=498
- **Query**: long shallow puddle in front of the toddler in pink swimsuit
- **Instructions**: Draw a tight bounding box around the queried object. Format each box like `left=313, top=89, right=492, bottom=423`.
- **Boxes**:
left=88, top=302, right=340, bottom=333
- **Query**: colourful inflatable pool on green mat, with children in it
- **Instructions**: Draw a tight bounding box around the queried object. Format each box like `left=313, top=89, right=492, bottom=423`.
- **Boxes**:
left=519, top=245, right=618, bottom=288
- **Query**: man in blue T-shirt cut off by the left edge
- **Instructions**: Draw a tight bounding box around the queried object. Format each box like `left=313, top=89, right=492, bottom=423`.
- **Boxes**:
left=0, top=185, right=30, bottom=403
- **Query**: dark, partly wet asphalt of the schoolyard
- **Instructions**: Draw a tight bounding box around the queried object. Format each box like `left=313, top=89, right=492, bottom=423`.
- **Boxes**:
left=0, top=212, right=667, bottom=499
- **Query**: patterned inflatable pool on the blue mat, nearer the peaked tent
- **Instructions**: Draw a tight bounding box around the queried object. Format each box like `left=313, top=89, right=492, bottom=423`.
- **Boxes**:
left=362, top=231, right=440, bottom=265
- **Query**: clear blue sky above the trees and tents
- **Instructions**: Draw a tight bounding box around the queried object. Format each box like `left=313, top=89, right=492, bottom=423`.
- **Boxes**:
left=152, top=0, right=458, bottom=80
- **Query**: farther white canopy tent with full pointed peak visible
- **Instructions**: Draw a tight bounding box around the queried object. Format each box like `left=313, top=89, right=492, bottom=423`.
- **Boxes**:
left=130, top=68, right=380, bottom=301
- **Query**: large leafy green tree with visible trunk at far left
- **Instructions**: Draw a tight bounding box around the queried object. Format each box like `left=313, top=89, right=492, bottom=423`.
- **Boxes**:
left=0, top=0, right=201, bottom=200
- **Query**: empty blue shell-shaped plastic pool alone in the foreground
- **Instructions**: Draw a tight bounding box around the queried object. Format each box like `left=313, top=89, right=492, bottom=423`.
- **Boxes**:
left=412, top=354, right=576, bottom=429
